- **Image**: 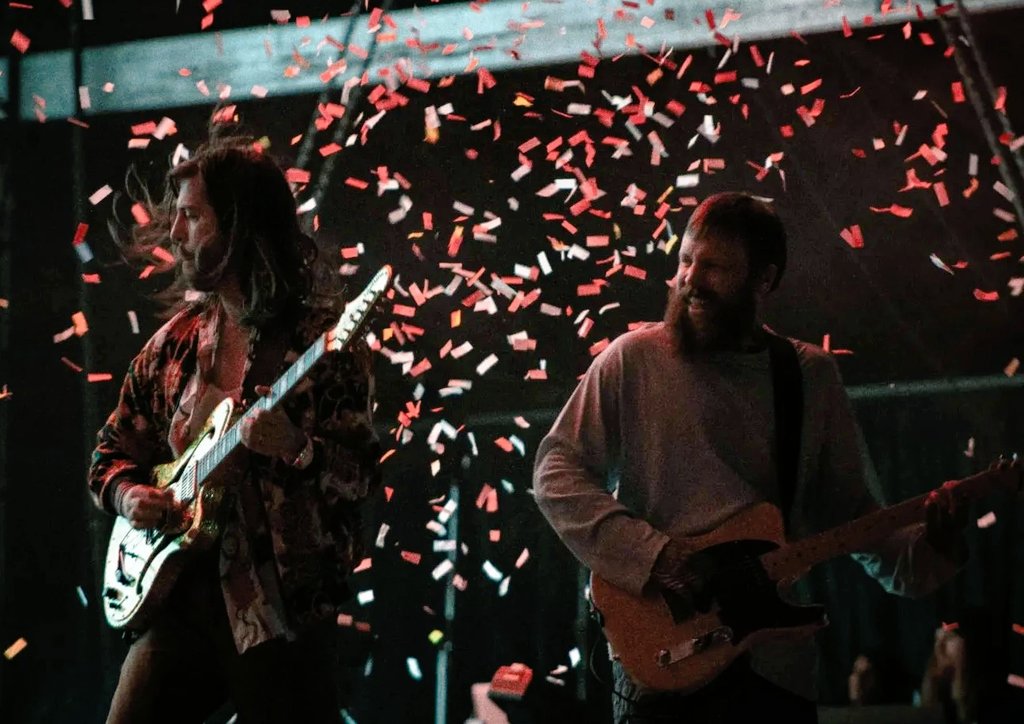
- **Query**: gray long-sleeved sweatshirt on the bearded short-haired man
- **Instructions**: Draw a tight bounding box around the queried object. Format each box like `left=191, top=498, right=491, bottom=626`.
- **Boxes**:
left=534, top=323, right=955, bottom=698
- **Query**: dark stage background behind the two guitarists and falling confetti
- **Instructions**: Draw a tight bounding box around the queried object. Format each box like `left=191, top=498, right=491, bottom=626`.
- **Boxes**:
left=0, top=3, right=1024, bottom=724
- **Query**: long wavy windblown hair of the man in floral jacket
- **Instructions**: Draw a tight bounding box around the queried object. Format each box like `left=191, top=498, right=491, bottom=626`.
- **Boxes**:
left=119, top=136, right=327, bottom=327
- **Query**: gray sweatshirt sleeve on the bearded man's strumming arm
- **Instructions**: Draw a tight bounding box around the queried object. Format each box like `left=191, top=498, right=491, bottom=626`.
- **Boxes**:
left=534, top=343, right=669, bottom=595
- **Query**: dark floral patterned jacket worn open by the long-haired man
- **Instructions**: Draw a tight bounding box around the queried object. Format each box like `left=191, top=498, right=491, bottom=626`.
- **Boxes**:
left=88, top=298, right=379, bottom=652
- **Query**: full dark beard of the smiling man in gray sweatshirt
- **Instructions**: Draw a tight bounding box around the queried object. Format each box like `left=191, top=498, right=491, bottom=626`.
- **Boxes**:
left=665, top=284, right=757, bottom=352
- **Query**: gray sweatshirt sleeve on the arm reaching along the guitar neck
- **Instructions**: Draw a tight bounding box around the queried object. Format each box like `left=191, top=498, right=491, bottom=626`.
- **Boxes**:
left=814, top=358, right=958, bottom=597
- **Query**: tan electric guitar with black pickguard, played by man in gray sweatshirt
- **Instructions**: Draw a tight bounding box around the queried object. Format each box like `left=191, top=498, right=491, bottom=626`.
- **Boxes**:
left=591, top=462, right=1021, bottom=693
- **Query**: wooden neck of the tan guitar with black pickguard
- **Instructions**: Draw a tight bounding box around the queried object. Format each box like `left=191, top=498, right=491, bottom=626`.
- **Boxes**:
left=761, top=471, right=1000, bottom=581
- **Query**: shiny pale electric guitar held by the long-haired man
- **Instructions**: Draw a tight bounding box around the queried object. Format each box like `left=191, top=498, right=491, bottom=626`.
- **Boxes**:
left=102, top=265, right=391, bottom=629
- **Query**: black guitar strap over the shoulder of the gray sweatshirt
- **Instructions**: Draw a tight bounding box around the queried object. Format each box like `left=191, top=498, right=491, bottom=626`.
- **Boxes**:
left=768, top=332, right=804, bottom=529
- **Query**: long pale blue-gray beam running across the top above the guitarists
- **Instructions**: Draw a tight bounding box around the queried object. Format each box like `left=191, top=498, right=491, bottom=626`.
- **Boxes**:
left=8, top=0, right=1024, bottom=120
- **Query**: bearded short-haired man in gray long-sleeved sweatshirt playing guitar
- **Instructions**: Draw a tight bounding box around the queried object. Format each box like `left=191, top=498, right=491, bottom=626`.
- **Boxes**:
left=534, top=193, right=967, bottom=724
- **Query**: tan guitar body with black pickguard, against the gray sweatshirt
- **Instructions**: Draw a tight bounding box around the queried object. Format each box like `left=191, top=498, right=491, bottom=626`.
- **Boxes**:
left=591, top=503, right=827, bottom=693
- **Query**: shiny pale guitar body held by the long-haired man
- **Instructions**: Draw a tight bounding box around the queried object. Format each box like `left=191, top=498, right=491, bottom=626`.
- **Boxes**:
left=102, top=398, right=234, bottom=629
